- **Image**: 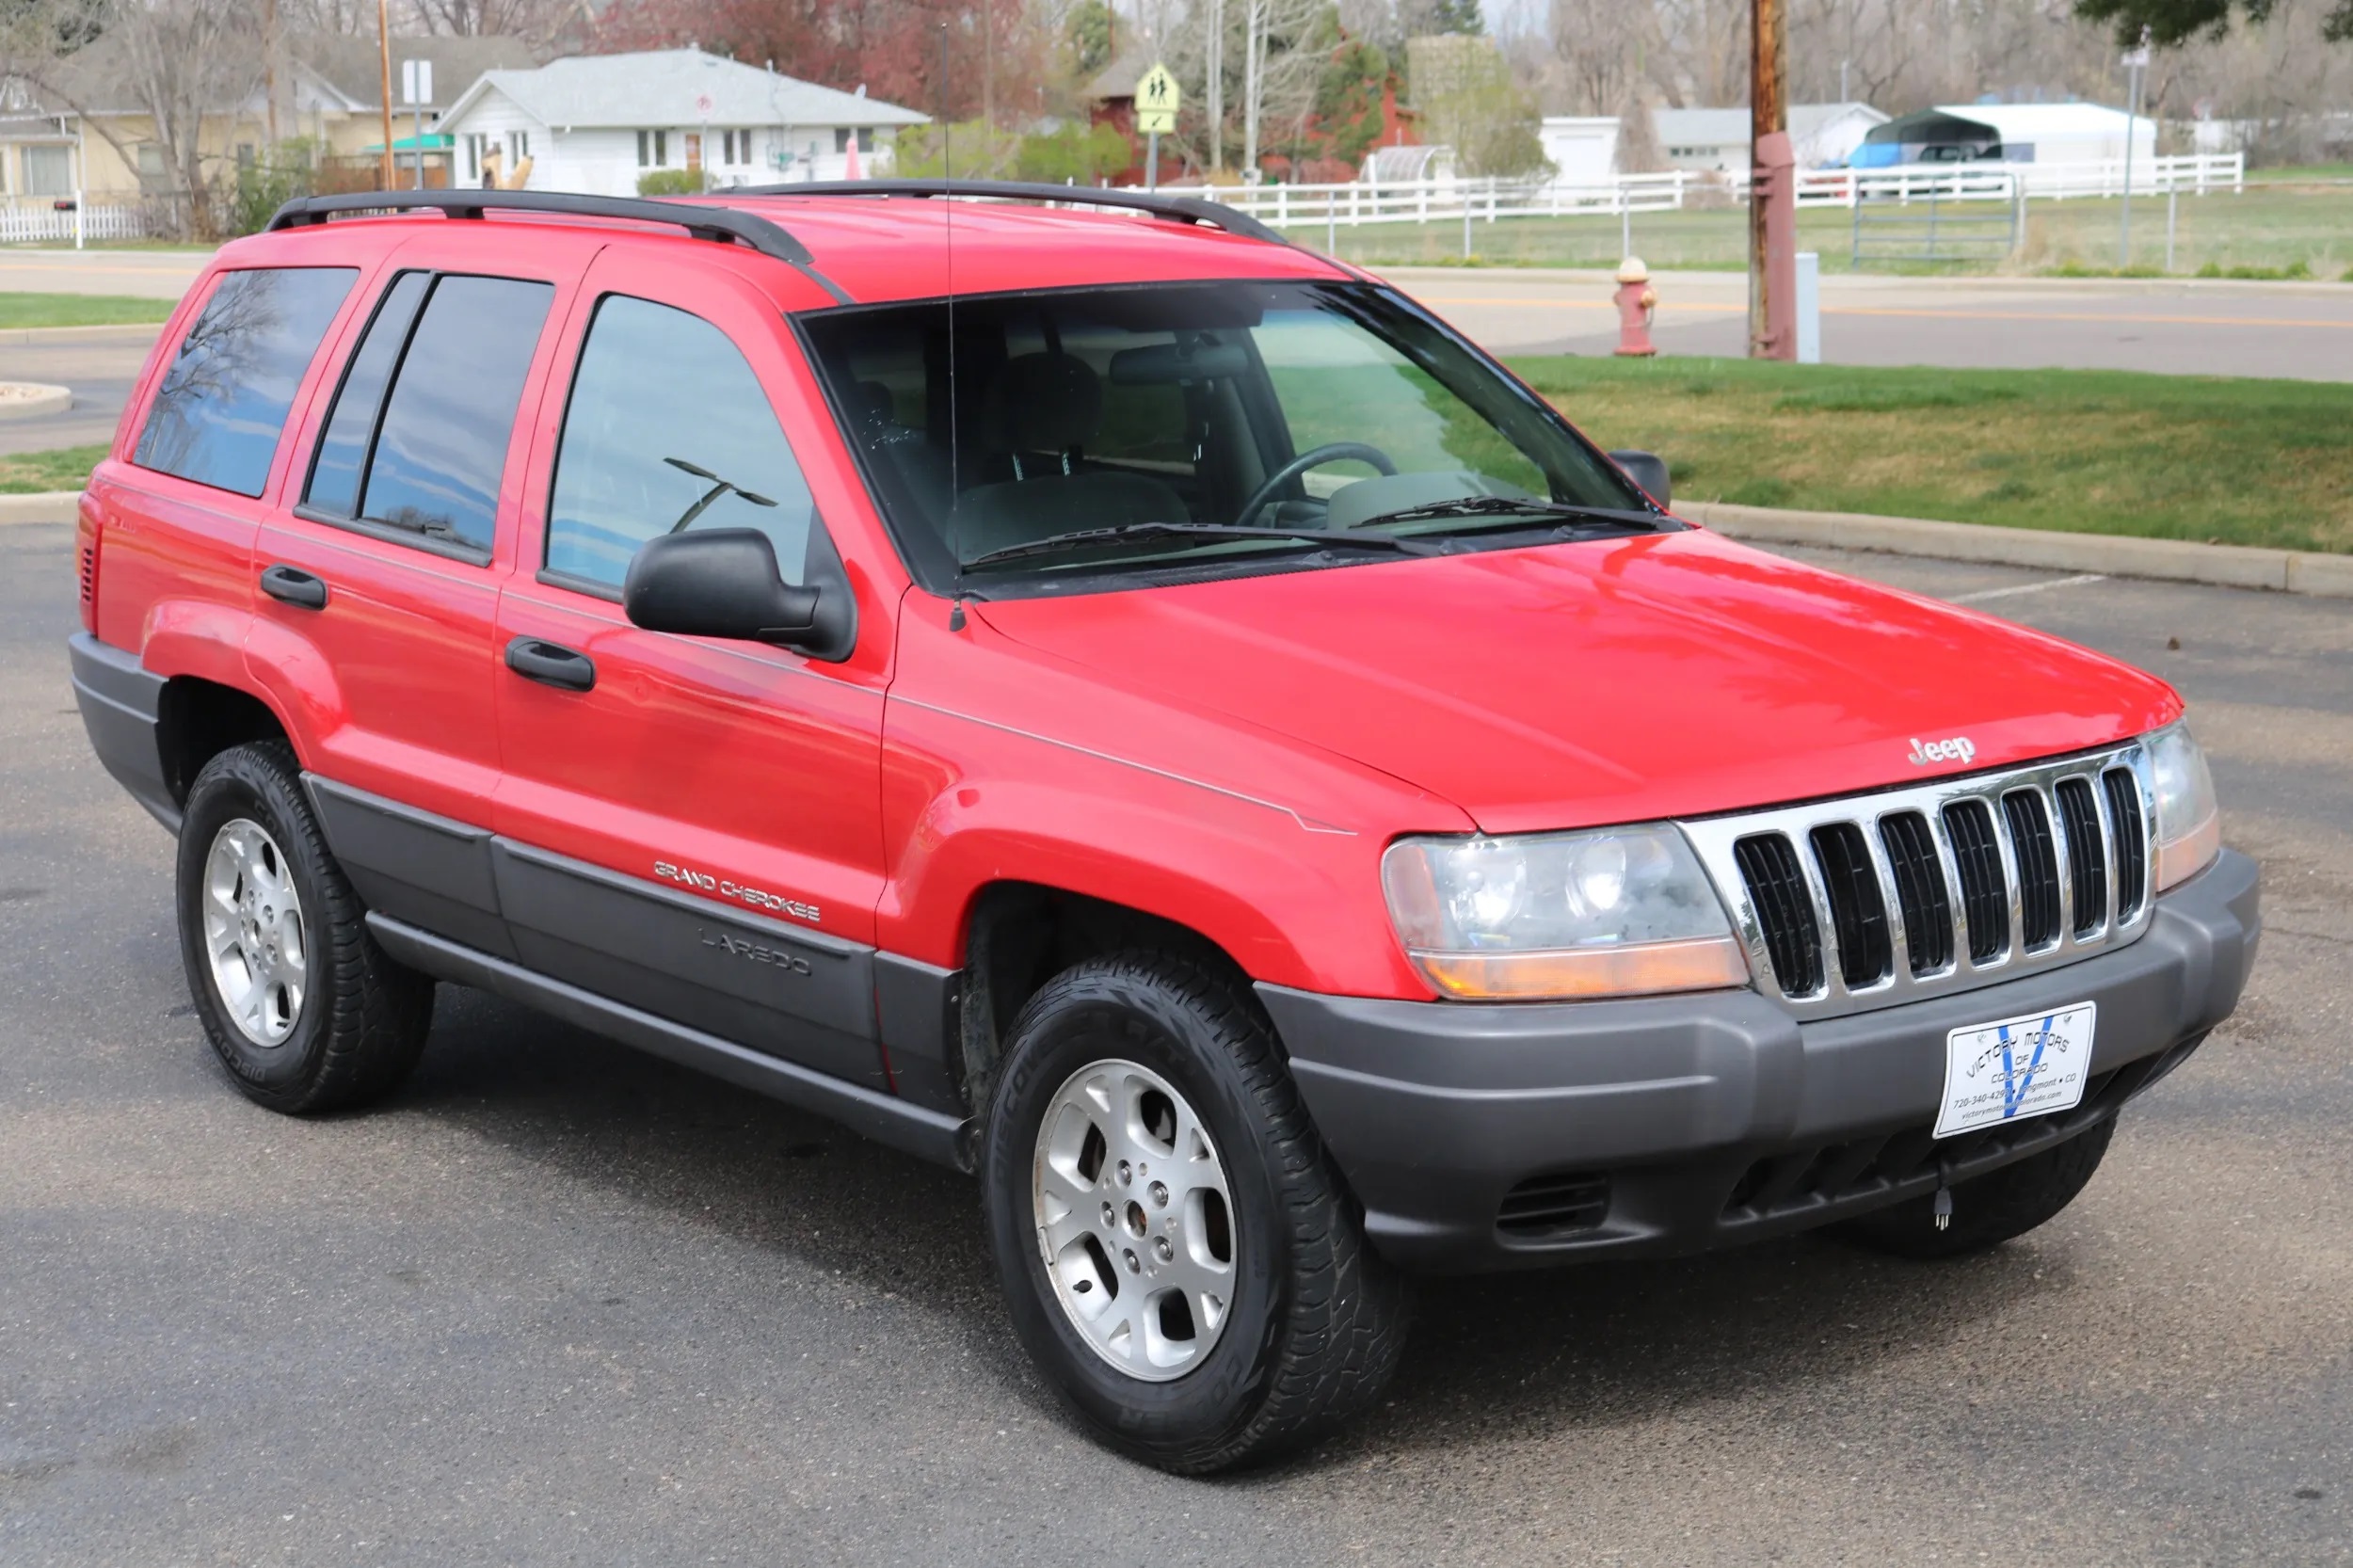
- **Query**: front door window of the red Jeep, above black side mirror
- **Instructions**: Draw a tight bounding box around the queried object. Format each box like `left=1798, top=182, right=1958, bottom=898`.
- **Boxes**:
left=549, top=295, right=814, bottom=588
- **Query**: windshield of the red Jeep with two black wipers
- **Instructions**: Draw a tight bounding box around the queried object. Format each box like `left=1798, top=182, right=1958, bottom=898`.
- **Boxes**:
left=800, top=282, right=1673, bottom=593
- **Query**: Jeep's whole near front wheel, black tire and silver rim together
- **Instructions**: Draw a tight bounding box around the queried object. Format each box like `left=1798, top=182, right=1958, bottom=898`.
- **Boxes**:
left=984, top=953, right=1405, bottom=1474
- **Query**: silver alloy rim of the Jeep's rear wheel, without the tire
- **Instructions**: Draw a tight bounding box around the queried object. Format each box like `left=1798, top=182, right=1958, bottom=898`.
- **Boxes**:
left=205, top=817, right=311, bottom=1046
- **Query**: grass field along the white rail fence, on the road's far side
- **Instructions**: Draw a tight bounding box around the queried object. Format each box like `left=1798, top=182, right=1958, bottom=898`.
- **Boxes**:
left=1288, top=184, right=2353, bottom=280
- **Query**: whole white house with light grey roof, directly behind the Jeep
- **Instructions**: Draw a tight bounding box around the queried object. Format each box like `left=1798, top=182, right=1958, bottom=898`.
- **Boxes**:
left=440, top=50, right=930, bottom=196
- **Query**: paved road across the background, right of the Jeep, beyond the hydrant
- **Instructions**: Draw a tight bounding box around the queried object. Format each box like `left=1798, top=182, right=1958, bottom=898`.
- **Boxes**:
left=1384, top=266, right=2353, bottom=381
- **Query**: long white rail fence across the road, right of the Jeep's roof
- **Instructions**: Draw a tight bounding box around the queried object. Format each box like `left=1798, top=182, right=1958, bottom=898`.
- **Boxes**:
left=1160, top=153, right=2248, bottom=229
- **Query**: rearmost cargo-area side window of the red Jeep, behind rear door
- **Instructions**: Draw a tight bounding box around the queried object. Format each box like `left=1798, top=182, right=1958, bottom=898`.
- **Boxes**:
left=132, top=266, right=360, bottom=494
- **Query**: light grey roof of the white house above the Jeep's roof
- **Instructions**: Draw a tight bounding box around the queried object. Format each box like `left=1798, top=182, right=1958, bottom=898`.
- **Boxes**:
left=442, top=50, right=930, bottom=130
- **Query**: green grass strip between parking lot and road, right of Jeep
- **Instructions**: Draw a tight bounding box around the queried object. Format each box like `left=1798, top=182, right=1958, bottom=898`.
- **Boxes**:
left=1513, top=356, right=2353, bottom=551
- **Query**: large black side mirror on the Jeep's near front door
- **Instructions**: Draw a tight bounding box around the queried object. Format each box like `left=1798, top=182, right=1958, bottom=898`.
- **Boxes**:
left=621, top=527, right=856, bottom=659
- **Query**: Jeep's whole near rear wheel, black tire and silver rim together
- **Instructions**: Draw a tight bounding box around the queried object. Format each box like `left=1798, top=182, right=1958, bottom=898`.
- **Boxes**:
left=179, top=742, right=433, bottom=1112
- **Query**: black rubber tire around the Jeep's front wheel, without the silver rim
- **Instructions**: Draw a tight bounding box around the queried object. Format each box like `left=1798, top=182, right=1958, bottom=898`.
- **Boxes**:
left=982, top=952, right=1407, bottom=1474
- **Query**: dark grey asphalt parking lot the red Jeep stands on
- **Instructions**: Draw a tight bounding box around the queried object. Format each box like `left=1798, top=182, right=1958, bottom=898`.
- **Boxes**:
left=0, top=527, right=2353, bottom=1568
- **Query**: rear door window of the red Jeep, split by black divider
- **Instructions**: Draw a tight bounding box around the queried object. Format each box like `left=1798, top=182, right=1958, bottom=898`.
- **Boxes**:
left=304, top=273, right=555, bottom=555
